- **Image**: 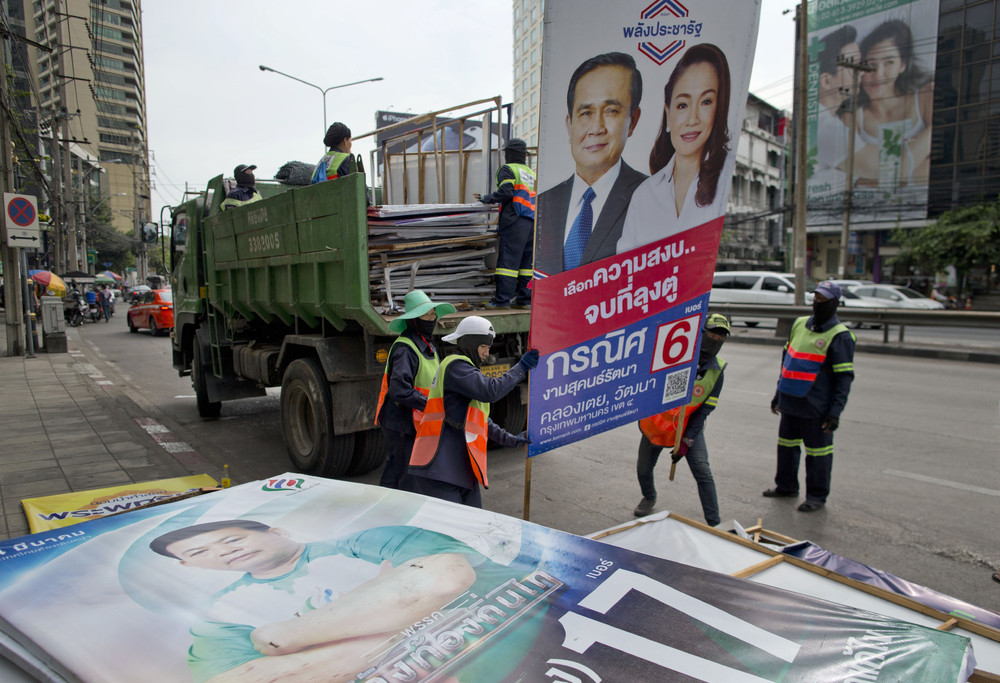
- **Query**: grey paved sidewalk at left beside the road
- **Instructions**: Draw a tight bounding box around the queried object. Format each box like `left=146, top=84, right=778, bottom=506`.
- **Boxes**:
left=0, top=311, right=192, bottom=539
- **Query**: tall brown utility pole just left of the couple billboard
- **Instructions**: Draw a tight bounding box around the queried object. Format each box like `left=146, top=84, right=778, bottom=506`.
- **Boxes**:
left=792, top=0, right=809, bottom=306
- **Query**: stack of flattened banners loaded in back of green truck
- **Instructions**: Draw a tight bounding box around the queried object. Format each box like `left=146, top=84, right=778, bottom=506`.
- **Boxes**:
left=368, top=203, right=496, bottom=312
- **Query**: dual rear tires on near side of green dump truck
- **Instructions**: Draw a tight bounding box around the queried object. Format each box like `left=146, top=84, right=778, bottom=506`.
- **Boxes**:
left=281, top=358, right=354, bottom=477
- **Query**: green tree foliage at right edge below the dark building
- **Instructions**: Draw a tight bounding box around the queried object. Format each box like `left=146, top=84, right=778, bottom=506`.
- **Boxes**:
left=896, top=199, right=1000, bottom=294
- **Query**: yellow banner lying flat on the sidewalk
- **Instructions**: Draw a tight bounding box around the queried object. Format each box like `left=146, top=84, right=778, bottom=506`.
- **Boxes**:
left=21, top=474, right=219, bottom=533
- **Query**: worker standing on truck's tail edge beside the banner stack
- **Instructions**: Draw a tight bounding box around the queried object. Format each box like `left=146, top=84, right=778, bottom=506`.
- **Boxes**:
left=474, top=138, right=535, bottom=308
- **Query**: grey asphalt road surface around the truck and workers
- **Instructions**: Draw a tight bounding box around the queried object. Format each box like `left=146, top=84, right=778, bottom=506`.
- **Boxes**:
left=71, top=314, right=1000, bottom=611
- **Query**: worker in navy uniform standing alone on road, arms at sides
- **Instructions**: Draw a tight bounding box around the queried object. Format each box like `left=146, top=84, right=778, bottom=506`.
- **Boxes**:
left=764, top=282, right=855, bottom=512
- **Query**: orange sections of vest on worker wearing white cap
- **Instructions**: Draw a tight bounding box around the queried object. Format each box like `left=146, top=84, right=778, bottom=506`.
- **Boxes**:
left=410, top=354, right=490, bottom=488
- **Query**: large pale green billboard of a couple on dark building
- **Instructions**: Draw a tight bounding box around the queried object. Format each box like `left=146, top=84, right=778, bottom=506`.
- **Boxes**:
left=807, top=0, right=938, bottom=225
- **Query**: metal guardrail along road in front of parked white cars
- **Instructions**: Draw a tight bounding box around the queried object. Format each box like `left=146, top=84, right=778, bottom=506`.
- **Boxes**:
left=708, top=303, right=1000, bottom=343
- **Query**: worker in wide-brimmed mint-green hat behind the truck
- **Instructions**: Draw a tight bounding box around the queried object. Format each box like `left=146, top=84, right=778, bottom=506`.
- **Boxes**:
left=375, top=289, right=455, bottom=490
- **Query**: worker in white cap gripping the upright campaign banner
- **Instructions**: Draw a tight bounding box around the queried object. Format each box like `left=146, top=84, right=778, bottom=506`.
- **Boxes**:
left=409, top=315, right=538, bottom=508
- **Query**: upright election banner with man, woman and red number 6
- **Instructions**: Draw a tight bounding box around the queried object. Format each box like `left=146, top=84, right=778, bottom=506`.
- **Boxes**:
left=528, top=0, right=760, bottom=455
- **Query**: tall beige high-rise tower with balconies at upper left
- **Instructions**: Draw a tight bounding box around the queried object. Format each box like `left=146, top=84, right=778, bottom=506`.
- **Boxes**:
left=25, top=0, right=152, bottom=271
